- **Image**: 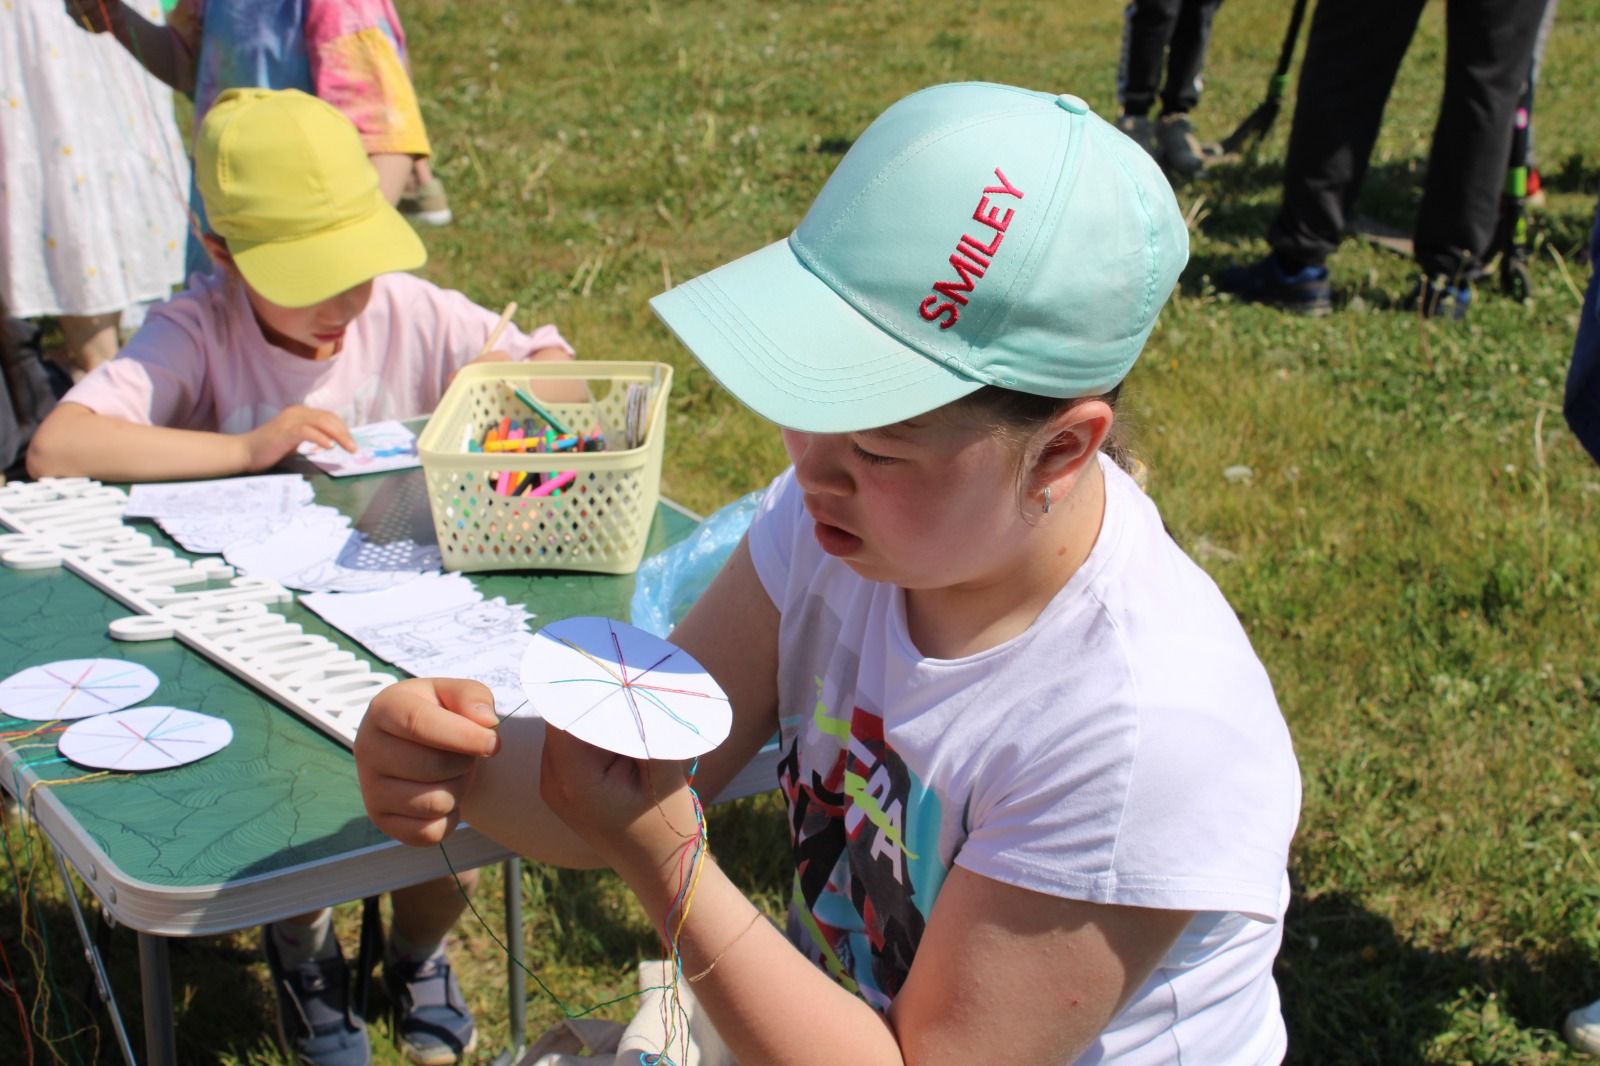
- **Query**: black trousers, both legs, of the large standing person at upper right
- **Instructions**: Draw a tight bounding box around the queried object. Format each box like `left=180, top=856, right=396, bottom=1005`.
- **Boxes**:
left=1267, top=0, right=1544, bottom=277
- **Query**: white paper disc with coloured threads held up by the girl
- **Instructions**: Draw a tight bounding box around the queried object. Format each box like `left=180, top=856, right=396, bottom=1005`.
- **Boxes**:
left=522, top=616, right=733, bottom=759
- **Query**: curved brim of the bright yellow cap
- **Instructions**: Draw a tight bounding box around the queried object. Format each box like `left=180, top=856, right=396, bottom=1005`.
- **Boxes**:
left=227, top=200, right=427, bottom=307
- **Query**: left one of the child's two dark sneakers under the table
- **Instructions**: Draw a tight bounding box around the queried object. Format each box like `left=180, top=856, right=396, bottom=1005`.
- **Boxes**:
left=261, top=925, right=373, bottom=1066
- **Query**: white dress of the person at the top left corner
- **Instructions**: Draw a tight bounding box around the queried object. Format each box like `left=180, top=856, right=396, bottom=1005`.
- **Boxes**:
left=0, top=0, right=189, bottom=319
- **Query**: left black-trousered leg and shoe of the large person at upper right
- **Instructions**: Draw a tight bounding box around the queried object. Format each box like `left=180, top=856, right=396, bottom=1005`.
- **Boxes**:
left=1216, top=0, right=1424, bottom=315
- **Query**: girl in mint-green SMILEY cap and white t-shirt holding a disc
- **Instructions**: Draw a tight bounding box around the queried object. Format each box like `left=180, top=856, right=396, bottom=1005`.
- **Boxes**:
left=355, top=85, right=1299, bottom=1066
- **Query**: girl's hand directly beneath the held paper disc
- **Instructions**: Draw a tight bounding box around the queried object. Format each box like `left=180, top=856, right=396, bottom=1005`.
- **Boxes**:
left=539, top=727, right=699, bottom=879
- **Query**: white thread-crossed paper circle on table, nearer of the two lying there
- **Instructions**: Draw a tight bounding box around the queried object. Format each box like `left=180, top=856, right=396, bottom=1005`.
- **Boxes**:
left=58, top=707, right=234, bottom=771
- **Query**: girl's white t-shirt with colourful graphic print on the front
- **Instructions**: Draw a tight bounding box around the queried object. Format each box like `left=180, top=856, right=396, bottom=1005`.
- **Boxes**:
left=749, top=459, right=1299, bottom=1066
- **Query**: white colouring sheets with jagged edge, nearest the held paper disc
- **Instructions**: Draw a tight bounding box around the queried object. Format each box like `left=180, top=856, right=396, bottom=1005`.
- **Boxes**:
left=301, top=573, right=533, bottom=717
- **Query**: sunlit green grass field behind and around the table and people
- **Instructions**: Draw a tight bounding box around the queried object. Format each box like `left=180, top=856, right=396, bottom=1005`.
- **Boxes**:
left=0, top=0, right=1600, bottom=1066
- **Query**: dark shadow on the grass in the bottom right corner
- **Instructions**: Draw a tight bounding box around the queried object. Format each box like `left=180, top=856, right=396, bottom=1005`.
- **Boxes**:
left=1277, top=893, right=1600, bottom=1066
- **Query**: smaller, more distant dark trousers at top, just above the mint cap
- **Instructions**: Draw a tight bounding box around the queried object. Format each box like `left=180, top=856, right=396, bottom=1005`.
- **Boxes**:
left=1117, top=0, right=1222, bottom=115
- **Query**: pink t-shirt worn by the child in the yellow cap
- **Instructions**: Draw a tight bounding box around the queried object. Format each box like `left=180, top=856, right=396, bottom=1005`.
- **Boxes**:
left=62, top=274, right=573, bottom=434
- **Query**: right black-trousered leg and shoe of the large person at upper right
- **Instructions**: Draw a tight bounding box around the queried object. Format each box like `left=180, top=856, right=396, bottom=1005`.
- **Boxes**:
left=1414, top=0, right=1544, bottom=317
